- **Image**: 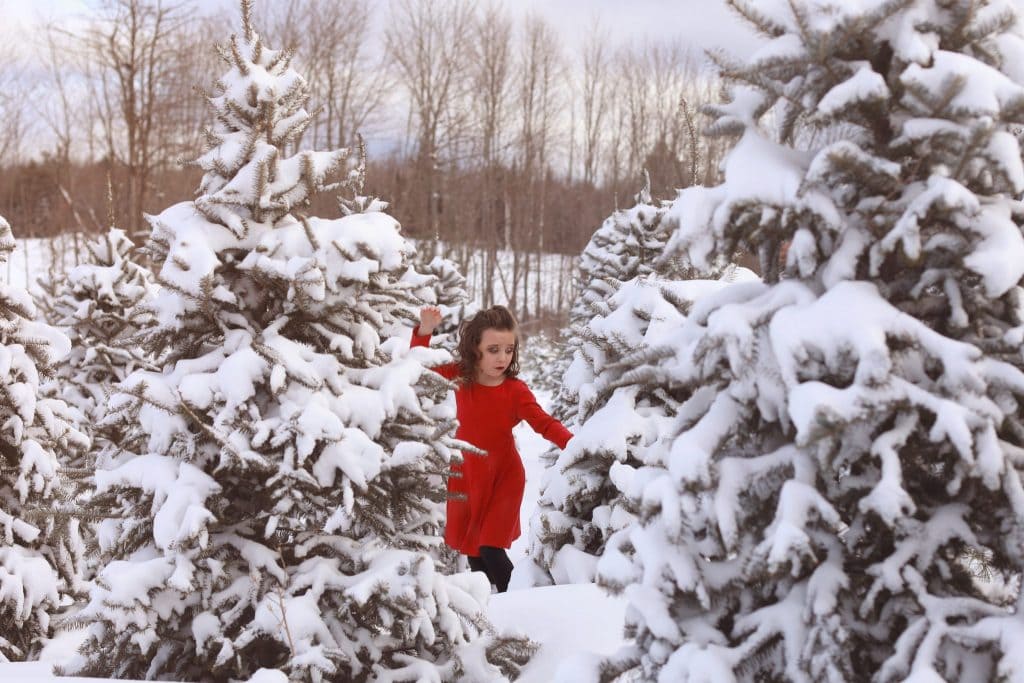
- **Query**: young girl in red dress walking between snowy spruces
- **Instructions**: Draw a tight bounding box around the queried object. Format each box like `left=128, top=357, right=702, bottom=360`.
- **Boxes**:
left=412, top=306, right=572, bottom=593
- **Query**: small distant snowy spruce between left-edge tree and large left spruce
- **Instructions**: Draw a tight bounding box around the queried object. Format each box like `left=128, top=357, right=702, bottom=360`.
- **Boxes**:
left=37, top=228, right=155, bottom=430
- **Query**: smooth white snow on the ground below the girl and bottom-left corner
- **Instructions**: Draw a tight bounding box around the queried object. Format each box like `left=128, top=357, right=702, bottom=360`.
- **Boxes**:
left=0, top=393, right=626, bottom=683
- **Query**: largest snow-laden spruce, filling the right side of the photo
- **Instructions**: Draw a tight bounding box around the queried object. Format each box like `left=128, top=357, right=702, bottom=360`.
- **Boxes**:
left=598, top=0, right=1024, bottom=681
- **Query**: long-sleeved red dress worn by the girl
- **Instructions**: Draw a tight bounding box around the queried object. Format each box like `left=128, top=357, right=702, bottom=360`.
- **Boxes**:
left=411, top=330, right=572, bottom=557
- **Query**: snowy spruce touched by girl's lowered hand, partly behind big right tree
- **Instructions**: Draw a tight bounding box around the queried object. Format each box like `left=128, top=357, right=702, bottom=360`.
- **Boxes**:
left=529, top=266, right=757, bottom=584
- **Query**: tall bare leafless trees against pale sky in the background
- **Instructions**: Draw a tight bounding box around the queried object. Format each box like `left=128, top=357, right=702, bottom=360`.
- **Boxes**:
left=0, top=0, right=725, bottom=319
